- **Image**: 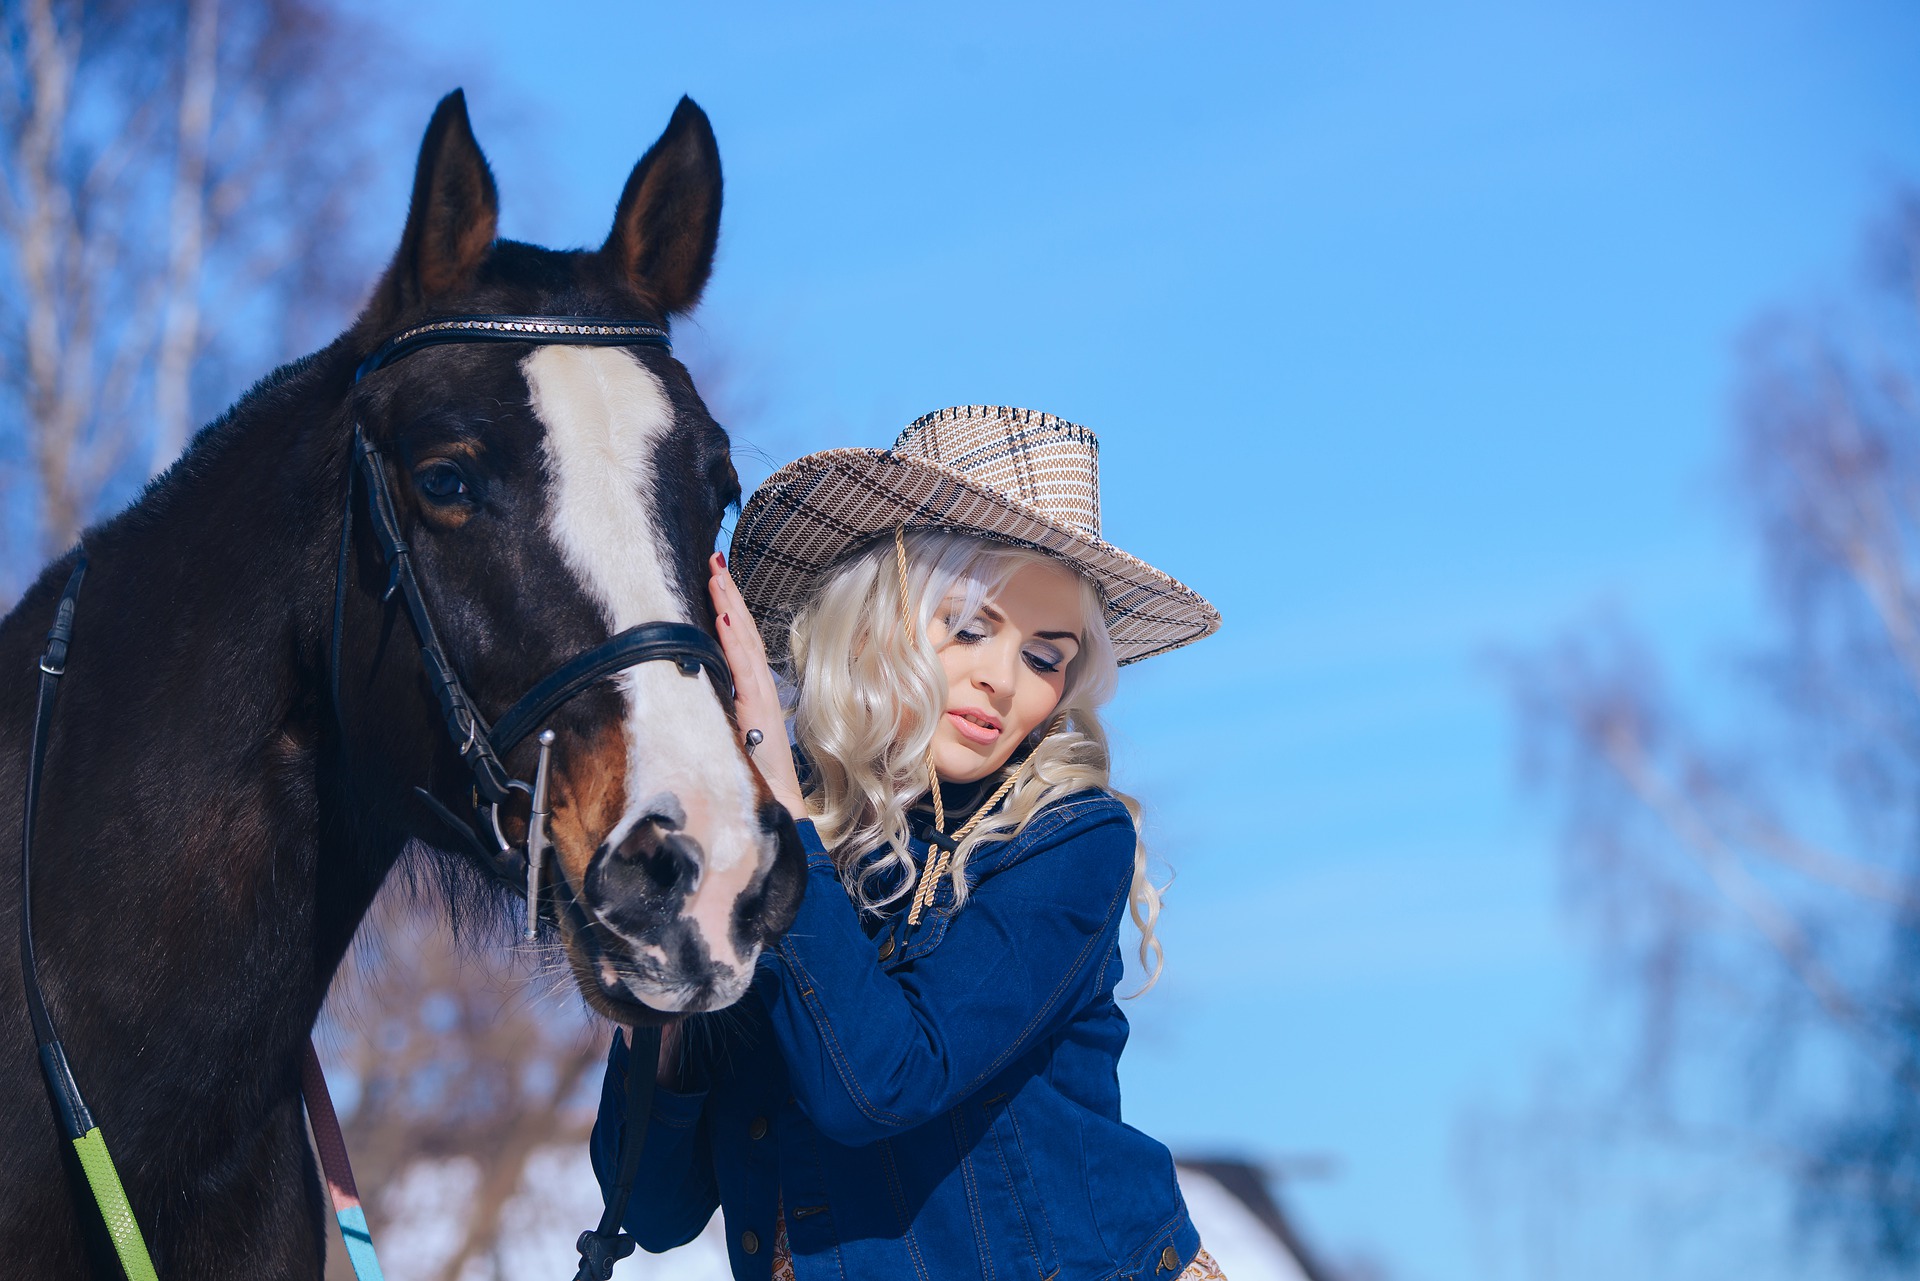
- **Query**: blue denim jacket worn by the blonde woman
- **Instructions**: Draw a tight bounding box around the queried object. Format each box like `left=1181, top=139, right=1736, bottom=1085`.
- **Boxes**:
left=591, top=791, right=1200, bottom=1281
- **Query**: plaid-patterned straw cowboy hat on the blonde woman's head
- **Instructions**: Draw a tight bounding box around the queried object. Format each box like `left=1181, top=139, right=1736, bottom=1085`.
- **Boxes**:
left=728, top=405, right=1219, bottom=663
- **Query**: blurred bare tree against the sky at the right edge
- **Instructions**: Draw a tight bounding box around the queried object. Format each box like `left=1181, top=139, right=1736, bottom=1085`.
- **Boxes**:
left=1511, top=198, right=1920, bottom=1275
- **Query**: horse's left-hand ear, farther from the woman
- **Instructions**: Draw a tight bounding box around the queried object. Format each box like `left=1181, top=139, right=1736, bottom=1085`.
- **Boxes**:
left=374, top=88, right=499, bottom=319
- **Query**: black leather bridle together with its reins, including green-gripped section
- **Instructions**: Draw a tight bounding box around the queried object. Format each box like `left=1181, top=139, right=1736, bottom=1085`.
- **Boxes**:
left=19, top=315, right=733, bottom=1281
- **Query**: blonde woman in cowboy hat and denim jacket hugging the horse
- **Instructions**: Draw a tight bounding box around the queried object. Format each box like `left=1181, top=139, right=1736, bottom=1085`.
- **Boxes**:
left=593, top=405, right=1219, bottom=1281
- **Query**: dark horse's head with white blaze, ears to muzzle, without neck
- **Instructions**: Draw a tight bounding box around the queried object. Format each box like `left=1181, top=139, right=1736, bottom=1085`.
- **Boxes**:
left=346, top=94, right=804, bottom=1022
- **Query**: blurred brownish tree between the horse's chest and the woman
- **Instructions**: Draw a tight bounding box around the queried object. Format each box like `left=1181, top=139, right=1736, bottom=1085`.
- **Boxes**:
left=317, top=874, right=611, bottom=1281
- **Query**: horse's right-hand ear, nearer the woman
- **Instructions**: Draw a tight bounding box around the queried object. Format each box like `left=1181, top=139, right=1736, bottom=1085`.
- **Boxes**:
left=601, top=98, right=720, bottom=315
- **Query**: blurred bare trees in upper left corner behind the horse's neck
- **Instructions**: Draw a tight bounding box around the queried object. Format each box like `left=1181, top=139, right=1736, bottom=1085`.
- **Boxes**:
left=0, top=0, right=392, bottom=580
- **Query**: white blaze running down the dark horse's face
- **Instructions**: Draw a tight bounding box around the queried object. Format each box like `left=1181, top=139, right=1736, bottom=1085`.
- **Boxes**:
left=522, top=346, right=770, bottom=1010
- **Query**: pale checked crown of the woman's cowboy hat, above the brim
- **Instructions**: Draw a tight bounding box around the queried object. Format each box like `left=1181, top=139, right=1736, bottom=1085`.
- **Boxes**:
left=893, top=405, right=1100, bottom=538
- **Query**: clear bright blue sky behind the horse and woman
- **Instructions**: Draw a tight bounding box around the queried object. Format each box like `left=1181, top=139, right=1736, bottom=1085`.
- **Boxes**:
left=349, top=0, right=1920, bottom=1281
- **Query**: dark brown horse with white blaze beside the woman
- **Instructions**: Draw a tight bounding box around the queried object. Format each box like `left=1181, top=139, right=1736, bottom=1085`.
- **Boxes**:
left=0, top=90, right=804, bottom=1279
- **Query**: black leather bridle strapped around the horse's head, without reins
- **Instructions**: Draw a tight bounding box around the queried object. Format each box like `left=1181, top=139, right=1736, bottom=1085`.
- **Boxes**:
left=328, top=315, right=733, bottom=939
